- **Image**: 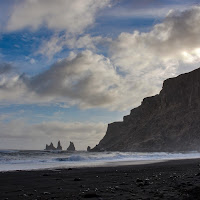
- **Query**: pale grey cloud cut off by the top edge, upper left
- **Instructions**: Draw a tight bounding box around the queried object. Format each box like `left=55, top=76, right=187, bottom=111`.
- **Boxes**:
left=6, top=0, right=110, bottom=33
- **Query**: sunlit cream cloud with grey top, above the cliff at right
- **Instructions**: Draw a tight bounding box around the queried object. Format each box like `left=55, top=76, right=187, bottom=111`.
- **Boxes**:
left=111, top=7, right=200, bottom=71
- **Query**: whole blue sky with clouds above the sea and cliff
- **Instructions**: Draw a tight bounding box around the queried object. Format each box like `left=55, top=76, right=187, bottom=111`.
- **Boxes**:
left=0, top=0, right=200, bottom=150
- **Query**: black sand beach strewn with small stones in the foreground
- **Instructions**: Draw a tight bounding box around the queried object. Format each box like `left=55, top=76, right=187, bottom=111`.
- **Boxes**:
left=0, top=159, right=200, bottom=200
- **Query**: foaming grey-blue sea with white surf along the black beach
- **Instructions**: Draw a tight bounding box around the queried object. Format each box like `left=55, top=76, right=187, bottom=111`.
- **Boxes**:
left=0, top=150, right=200, bottom=172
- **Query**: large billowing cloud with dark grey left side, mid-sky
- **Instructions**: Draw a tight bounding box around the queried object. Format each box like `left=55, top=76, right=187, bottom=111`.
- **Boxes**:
left=27, top=51, right=120, bottom=108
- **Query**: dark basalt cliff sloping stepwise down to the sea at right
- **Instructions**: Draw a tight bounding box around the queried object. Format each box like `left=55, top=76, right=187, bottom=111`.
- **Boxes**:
left=92, top=68, right=200, bottom=152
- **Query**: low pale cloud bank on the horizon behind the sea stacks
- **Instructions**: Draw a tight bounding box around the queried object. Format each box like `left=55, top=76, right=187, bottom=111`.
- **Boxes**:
left=0, top=117, right=107, bottom=150
